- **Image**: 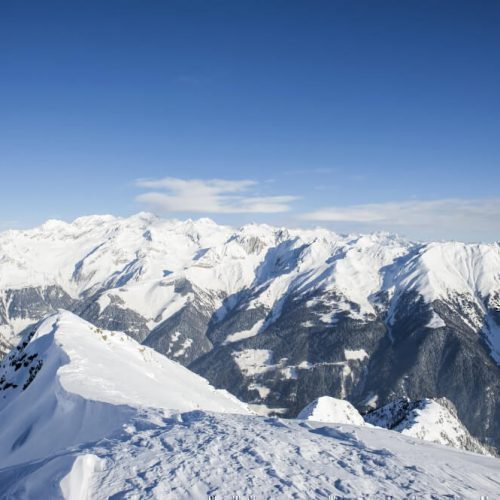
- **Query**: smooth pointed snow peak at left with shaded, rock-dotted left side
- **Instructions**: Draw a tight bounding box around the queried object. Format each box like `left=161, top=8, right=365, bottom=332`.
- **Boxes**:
left=0, top=312, right=248, bottom=467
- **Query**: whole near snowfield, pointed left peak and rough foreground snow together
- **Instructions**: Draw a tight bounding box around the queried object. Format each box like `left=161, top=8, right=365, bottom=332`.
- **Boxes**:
left=0, top=312, right=500, bottom=500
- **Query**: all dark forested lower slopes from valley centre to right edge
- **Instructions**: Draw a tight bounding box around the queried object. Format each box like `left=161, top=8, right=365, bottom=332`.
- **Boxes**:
left=189, top=294, right=500, bottom=447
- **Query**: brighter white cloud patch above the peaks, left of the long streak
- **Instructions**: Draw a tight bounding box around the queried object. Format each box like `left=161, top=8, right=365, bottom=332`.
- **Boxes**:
left=136, top=177, right=298, bottom=214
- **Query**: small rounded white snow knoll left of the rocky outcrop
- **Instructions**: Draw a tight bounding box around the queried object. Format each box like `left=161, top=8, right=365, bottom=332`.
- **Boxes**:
left=297, top=396, right=365, bottom=425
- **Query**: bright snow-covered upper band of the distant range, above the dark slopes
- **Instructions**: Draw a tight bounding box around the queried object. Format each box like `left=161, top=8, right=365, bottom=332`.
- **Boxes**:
left=0, top=213, right=500, bottom=316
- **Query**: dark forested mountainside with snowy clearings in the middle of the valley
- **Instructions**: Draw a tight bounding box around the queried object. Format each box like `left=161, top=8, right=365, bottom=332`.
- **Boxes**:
left=189, top=288, right=386, bottom=417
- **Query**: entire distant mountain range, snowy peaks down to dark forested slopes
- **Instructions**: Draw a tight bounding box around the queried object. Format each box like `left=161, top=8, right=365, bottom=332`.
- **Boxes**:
left=0, top=213, right=500, bottom=448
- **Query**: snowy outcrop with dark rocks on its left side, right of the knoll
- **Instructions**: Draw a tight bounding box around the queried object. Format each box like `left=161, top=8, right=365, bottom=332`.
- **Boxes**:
left=365, top=398, right=489, bottom=455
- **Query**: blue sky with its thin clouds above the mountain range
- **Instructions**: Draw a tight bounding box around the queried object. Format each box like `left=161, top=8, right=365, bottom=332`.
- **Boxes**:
left=0, top=0, right=500, bottom=241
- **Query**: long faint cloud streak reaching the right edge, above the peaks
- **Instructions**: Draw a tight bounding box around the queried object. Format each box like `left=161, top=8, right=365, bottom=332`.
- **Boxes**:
left=300, top=198, right=500, bottom=238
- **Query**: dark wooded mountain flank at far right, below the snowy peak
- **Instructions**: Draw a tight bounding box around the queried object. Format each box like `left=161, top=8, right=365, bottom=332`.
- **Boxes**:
left=353, top=296, right=500, bottom=447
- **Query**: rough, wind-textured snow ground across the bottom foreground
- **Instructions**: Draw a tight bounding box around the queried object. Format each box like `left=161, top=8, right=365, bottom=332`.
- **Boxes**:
left=0, top=410, right=500, bottom=499
